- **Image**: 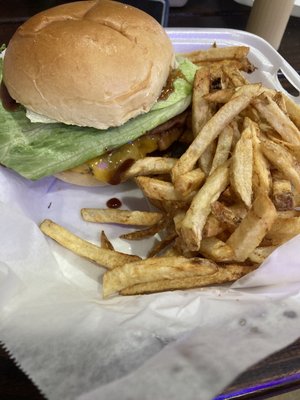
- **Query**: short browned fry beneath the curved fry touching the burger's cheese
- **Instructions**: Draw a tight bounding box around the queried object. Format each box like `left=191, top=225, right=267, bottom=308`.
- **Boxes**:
left=135, top=176, right=194, bottom=201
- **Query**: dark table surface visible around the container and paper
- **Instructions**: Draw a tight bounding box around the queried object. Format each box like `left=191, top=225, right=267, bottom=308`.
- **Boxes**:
left=0, top=0, right=300, bottom=400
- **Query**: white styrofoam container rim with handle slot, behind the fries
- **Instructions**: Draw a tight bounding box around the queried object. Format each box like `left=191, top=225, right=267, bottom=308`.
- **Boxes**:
left=166, top=28, right=300, bottom=103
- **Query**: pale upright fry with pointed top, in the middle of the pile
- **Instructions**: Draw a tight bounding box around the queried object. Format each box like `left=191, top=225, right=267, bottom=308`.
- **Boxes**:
left=230, top=118, right=253, bottom=207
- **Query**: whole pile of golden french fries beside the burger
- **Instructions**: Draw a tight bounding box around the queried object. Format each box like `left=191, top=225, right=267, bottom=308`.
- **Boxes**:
left=40, top=46, right=300, bottom=297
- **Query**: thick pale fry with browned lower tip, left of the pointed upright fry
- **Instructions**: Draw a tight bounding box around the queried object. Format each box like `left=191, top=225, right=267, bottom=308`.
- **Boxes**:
left=181, top=162, right=229, bottom=251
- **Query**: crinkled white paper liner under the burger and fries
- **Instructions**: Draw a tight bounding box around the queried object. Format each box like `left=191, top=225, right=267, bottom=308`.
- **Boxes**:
left=0, top=167, right=300, bottom=400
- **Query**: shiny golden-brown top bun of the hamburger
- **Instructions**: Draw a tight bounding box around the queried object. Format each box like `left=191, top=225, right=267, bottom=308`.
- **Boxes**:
left=3, top=0, right=174, bottom=129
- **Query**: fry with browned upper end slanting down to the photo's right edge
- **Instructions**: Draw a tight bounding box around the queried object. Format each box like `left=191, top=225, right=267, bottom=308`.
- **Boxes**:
left=253, top=93, right=300, bottom=145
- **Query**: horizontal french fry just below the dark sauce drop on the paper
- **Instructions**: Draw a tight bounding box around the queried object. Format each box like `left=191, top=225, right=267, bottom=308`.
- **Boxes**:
left=81, top=208, right=163, bottom=226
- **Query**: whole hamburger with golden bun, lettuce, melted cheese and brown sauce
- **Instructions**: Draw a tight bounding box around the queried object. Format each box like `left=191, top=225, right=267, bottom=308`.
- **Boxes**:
left=0, top=0, right=196, bottom=185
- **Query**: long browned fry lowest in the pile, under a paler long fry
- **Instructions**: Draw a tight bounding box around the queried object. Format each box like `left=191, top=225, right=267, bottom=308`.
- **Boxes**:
left=120, top=264, right=257, bottom=295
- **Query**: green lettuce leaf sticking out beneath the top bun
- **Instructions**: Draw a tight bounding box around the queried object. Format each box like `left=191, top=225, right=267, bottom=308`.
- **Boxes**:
left=0, top=55, right=197, bottom=180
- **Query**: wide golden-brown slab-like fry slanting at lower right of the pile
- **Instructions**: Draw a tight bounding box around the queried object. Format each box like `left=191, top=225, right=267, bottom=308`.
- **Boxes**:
left=226, top=194, right=277, bottom=261
